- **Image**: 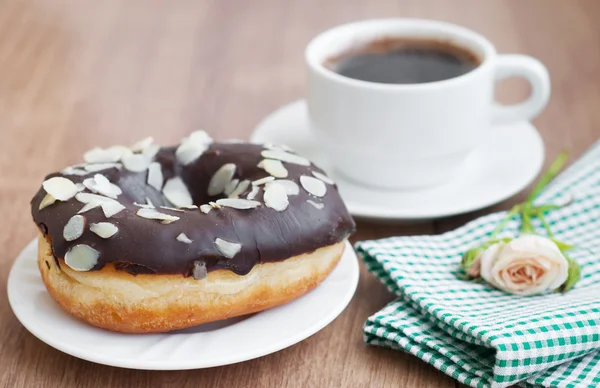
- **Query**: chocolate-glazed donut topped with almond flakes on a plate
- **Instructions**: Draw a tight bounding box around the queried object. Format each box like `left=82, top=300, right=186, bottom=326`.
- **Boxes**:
left=31, top=131, right=355, bottom=333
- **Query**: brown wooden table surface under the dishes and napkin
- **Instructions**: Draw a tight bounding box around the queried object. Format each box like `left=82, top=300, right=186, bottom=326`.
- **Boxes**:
left=0, top=0, right=600, bottom=388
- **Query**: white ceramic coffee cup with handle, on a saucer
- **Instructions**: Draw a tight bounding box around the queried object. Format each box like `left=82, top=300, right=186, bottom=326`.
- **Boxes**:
left=305, top=19, right=550, bottom=189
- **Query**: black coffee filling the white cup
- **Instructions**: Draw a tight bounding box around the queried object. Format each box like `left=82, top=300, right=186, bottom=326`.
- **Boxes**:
left=325, top=38, right=481, bottom=84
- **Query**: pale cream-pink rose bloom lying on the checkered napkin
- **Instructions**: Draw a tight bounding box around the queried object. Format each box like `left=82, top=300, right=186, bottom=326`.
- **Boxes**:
left=478, top=235, right=569, bottom=295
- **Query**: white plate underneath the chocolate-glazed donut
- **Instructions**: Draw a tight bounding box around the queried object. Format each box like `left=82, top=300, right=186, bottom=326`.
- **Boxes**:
left=8, top=241, right=358, bottom=370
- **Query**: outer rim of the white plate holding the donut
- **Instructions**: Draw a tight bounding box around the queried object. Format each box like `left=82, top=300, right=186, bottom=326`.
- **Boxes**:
left=7, top=239, right=360, bottom=370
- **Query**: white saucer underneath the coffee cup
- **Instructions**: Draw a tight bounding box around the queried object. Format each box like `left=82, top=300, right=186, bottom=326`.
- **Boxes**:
left=250, top=100, right=544, bottom=220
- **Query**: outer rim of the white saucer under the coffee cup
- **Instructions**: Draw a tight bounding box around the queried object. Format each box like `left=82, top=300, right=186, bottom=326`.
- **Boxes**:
left=250, top=98, right=546, bottom=221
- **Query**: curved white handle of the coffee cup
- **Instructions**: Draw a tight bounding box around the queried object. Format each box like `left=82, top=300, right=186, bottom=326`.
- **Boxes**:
left=492, top=54, right=550, bottom=124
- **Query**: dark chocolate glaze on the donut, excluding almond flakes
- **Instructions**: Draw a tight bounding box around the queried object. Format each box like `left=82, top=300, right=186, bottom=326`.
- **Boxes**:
left=31, top=143, right=355, bottom=276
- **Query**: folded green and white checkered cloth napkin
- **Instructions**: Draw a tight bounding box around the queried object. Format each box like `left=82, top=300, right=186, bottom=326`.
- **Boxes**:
left=356, top=142, right=600, bottom=387
